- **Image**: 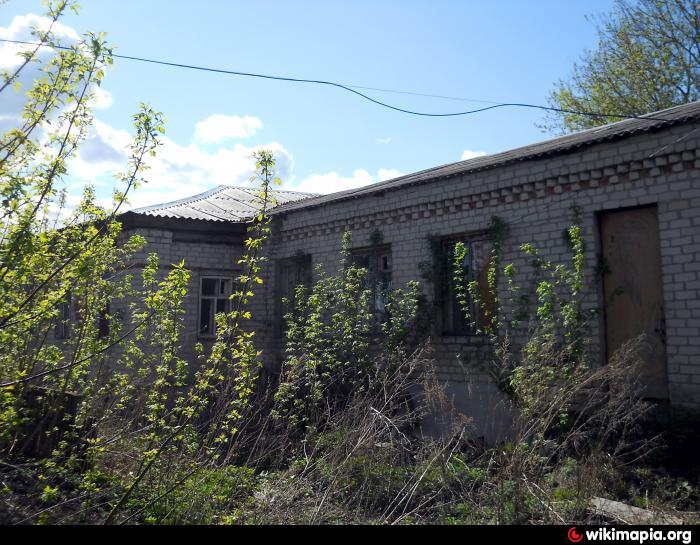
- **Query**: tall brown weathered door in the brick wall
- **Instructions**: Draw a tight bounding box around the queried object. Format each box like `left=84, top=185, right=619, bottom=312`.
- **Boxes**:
left=600, top=206, right=668, bottom=399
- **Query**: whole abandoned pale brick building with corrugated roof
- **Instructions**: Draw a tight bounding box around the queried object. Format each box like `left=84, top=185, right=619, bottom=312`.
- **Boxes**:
left=122, top=102, right=700, bottom=436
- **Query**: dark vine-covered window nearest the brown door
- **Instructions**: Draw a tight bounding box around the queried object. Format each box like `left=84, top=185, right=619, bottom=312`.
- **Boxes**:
left=438, top=235, right=493, bottom=335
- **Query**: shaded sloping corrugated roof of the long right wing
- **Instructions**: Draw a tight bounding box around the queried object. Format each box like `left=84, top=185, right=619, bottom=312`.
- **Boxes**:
left=274, top=101, right=700, bottom=213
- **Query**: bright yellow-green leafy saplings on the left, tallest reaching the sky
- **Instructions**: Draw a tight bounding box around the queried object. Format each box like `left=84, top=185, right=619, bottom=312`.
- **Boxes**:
left=0, top=0, right=276, bottom=523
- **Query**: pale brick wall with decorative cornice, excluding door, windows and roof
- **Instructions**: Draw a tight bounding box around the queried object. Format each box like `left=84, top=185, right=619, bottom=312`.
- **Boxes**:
left=121, top=122, right=700, bottom=416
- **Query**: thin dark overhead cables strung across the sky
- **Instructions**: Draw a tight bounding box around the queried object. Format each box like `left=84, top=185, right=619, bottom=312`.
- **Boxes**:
left=0, top=38, right=668, bottom=121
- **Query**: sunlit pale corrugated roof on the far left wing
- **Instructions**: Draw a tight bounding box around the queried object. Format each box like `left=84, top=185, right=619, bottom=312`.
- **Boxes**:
left=129, top=185, right=315, bottom=222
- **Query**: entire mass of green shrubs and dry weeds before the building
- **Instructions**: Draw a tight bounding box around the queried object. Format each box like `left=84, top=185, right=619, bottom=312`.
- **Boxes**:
left=0, top=2, right=698, bottom=524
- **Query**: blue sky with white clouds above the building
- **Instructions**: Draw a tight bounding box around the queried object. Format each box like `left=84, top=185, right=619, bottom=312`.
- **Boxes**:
left=0, top=0, right=613, bottom=210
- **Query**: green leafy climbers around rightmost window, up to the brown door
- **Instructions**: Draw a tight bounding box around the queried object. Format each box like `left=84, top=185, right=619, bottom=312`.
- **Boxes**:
left=452, top=218, right=588, bottom=416
